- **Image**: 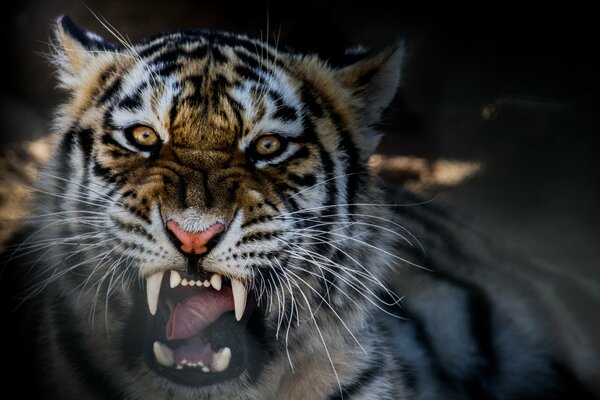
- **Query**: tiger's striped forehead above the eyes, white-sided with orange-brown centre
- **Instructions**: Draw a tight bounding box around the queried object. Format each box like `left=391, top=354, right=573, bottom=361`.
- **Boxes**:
left=104, top=33, right=302, bottom=149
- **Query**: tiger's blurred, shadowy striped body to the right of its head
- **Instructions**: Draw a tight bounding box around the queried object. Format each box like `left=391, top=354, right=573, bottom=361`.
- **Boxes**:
left=384, top=188, right=600, bottom=399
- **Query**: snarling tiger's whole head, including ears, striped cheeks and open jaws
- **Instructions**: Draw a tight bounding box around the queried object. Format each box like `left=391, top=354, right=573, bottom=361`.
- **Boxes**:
left=43, top=17, right=402, bottom=398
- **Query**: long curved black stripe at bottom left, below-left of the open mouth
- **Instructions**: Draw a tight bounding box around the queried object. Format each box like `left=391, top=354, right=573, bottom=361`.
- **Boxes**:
left=52, top=297, right=123, bottom=399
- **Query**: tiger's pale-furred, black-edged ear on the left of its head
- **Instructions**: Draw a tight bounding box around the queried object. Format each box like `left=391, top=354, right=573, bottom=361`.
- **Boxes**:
left=55, top=15, right=120, bottom=75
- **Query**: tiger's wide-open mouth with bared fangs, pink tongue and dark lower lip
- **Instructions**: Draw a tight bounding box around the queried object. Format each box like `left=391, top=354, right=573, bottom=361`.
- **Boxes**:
left=145, top=270, right=256, bottom=386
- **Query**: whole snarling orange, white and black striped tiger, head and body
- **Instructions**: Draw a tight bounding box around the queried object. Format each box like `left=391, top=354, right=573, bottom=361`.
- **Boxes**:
left=2, top=16, right=596, bottom=400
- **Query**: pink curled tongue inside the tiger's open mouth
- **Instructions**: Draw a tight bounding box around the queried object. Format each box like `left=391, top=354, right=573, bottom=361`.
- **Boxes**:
left=166, top=286, right=234, bottom=340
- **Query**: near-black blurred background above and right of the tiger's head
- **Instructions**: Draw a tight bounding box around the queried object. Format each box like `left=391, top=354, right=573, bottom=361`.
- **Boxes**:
left=0, top=0, right=600, bottom=279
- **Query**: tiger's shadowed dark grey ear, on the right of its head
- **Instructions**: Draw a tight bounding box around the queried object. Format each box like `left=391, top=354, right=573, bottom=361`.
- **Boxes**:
left=337, top=42, right=405, bottom=125
